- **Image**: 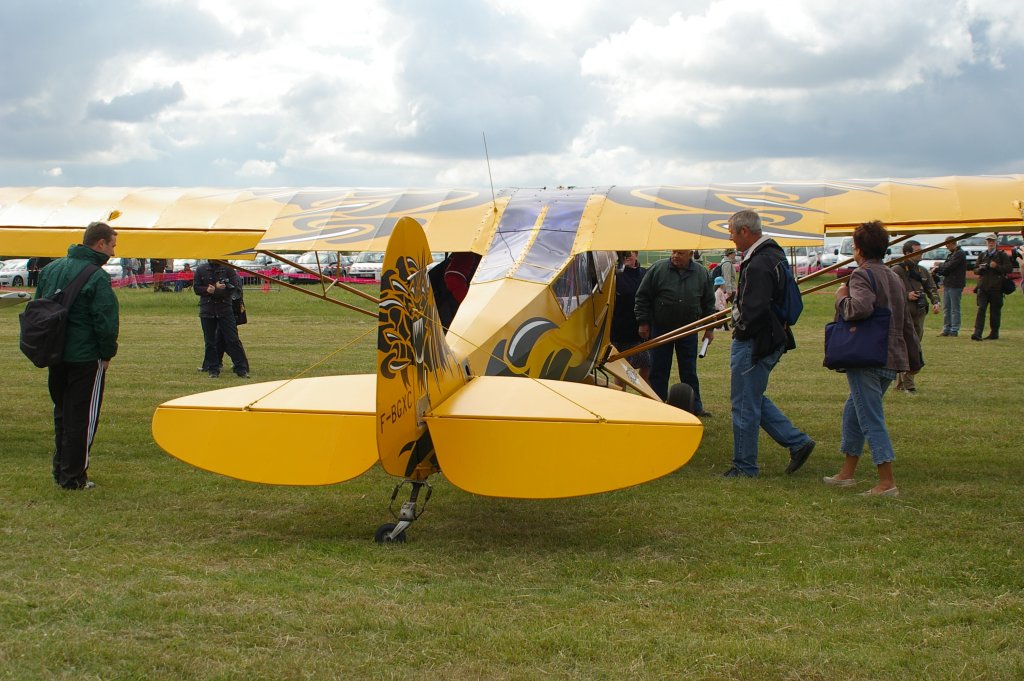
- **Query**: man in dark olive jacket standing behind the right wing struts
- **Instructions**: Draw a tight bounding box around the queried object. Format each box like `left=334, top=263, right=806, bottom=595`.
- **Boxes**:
left=634, top=250, right=715, bottom=416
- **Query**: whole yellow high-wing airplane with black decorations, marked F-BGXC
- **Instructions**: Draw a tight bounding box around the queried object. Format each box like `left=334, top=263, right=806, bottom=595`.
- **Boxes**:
left=0, top=175, right=1024, bottom=542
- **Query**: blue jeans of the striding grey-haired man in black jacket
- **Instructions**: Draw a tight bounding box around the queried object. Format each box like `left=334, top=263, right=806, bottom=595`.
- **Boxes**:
left=729, top=339, right=811, bottom=476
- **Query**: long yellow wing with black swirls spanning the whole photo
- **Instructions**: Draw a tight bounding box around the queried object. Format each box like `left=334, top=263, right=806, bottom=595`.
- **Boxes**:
left=0, top=175, right=1024, bottom=258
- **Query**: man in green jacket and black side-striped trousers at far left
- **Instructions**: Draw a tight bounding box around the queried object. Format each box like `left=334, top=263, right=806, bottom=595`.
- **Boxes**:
left=36, top=222, right=118, bottom=490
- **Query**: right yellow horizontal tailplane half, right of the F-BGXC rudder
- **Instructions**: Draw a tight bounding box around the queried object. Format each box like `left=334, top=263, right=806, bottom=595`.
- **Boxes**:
left=426, top=376, right=703, bottom=499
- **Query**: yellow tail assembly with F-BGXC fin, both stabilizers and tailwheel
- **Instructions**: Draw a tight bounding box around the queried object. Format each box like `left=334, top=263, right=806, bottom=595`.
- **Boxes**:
left=153, top=220, right=703, bottom=541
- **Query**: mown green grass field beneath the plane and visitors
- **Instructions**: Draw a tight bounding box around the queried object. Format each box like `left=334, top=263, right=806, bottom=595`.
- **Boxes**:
left=0, top=280, right=1024, bottom=679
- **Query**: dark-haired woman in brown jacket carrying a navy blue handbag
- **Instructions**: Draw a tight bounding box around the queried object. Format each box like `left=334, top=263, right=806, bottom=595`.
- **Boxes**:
left=823, top=220, right=924, bottom=497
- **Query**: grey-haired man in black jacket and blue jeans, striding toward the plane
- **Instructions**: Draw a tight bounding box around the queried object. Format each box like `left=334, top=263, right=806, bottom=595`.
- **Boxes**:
left=725, top=210, right=814, bottom=477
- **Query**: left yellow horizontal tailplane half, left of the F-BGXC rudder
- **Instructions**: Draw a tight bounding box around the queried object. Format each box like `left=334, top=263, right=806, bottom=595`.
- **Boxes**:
left=153, top=375, right=377, bottom=485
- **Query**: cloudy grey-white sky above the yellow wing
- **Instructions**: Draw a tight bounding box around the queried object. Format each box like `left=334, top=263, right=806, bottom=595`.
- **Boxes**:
left=0, top=0, right=1024, bottom=187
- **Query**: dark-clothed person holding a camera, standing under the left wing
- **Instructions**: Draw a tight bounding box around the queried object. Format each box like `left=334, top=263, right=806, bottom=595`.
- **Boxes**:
left=193, top=260, right=249, bottom=378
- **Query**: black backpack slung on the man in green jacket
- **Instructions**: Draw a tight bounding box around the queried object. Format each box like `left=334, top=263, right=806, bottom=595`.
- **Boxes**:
left=18, top=264, right=99, bottom=369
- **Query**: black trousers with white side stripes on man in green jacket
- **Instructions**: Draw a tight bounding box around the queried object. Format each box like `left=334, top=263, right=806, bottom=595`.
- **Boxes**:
left=49, top=359, right=106, bottom=488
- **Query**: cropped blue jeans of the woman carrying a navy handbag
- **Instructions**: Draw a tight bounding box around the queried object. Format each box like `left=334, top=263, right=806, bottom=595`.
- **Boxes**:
left=840, top=369, right=896, bottom=466
